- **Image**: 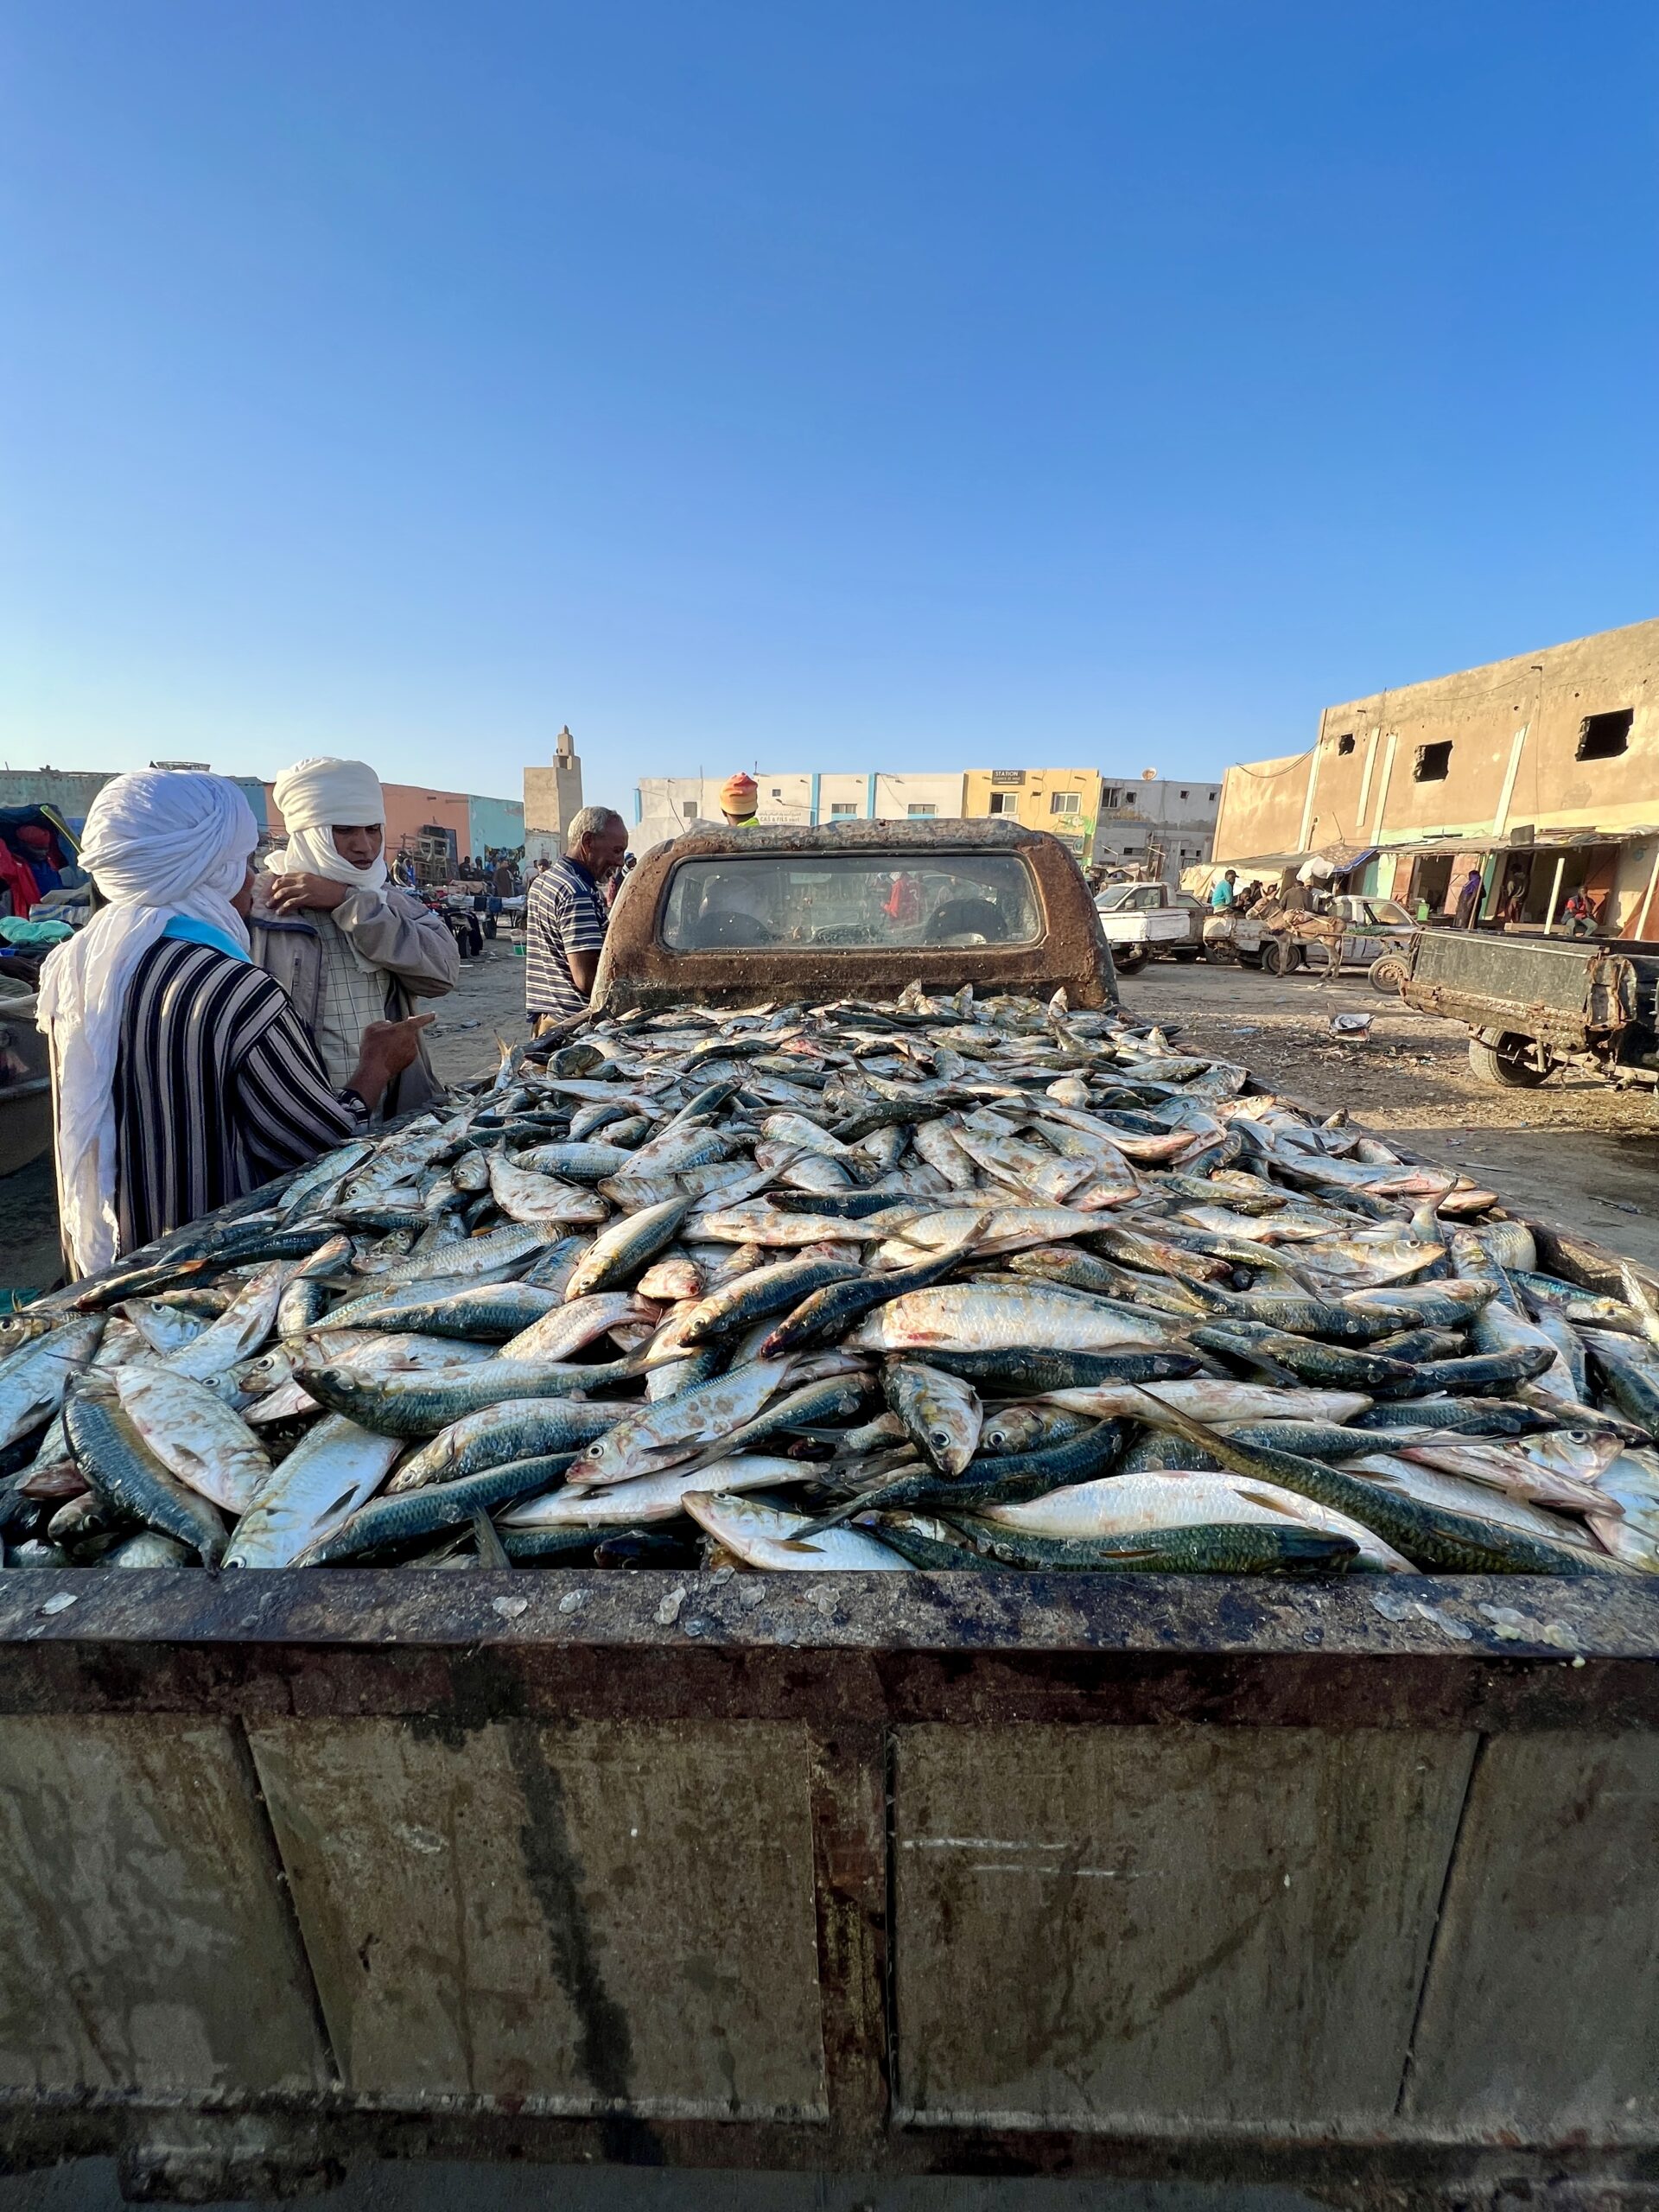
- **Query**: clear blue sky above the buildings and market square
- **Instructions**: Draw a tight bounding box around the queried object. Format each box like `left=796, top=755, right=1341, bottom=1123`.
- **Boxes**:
left=0, top=0, right=1659, bottom=805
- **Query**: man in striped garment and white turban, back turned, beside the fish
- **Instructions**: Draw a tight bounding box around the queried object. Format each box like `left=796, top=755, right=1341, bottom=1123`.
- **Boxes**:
left=38, top=770, right=431, bottom=1274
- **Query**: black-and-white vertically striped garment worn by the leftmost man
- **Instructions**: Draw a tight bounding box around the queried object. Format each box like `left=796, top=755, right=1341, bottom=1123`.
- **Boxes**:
left=115, top=938, right=365, bottom=1252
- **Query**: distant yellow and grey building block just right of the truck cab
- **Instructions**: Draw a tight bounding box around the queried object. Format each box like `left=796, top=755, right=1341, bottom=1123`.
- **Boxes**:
left=963, top=767, right=1221, bottom=880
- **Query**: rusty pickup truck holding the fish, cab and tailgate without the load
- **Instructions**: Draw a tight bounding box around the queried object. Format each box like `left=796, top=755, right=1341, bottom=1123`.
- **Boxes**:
left=0, top=825, right=1659, bottom=2212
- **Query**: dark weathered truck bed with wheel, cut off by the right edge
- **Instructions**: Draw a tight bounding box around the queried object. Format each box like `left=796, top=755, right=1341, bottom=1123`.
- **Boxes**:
left=1400, top=929, right=1659, bottom=1086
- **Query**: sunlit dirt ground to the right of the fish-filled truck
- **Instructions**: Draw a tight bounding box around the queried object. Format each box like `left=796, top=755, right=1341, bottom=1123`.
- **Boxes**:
left=1122, top=960, right=1659, bottom=1265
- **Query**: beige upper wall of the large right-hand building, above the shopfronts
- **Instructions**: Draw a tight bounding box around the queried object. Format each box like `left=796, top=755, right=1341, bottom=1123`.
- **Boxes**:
left=1214, top=621, right=1659, bottom=861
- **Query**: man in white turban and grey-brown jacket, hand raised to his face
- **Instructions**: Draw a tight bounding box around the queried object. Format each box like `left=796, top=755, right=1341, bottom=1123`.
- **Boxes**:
left=252, top=759, right=460, bottom=1113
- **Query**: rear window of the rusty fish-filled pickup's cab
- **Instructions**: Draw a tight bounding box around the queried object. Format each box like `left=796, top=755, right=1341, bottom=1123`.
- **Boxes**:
left=661, top=852, right=1042, bottom=953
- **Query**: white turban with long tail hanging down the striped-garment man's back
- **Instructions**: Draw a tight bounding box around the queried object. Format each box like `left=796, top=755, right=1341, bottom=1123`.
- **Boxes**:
left=38, top=767, right=259, bottom=1274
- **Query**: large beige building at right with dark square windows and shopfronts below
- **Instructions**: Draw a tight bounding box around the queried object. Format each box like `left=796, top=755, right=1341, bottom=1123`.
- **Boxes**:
left=1214, top=621, right=1659, bottom=936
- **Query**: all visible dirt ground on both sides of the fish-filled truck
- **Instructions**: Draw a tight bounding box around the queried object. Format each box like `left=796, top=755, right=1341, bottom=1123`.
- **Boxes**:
left=0, top=936, right=1659, bottom=1285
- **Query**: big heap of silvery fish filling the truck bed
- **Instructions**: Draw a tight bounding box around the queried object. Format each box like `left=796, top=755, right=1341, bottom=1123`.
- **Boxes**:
left=0, top=984, right=1659, bottom=1575
